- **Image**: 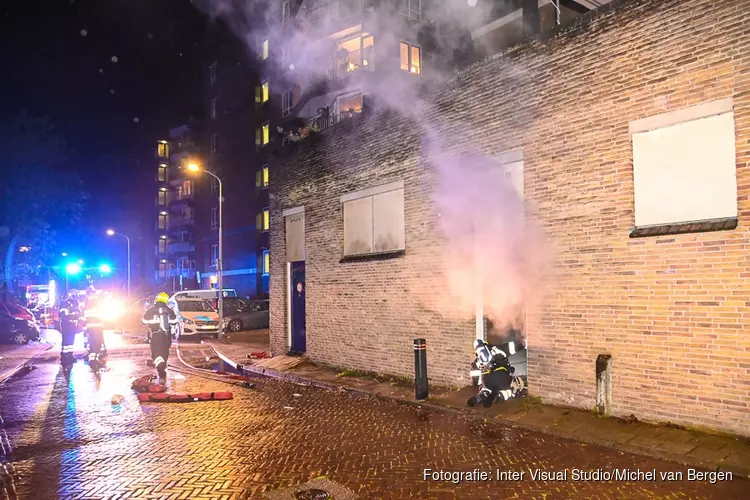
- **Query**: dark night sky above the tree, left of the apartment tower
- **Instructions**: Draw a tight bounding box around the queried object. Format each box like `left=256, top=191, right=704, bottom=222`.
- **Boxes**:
left=0, top=0, right=216, bottom=270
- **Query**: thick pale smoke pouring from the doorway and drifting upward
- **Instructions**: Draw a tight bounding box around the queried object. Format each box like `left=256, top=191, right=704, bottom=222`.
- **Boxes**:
left=195, top=0, right=550, bottom=340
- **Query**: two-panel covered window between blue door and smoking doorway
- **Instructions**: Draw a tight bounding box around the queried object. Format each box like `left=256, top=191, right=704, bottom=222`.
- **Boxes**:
left=341, top=182, right=406, bottom=257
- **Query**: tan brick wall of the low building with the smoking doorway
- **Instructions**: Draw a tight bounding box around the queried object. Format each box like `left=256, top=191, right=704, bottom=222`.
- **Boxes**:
left=271, top=0, right=750, bottom=435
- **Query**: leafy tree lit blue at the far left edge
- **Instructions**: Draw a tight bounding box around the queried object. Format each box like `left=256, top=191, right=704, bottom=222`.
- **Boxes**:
left=0, top=113, right=87, bottom=289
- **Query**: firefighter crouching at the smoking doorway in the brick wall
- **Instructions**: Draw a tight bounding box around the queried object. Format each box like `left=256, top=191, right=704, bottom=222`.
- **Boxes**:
left=467, top=339, right=526, bottom=408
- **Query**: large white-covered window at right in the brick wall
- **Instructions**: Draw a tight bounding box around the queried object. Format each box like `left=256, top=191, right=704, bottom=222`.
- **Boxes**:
left=630, top=98, right=738, bottom=236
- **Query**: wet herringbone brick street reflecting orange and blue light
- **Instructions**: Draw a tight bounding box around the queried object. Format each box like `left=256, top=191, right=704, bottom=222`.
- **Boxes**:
left=0, top=334, right=750, bottom=500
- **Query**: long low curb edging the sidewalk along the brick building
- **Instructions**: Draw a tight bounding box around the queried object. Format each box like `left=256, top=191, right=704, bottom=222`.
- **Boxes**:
left=206, top=344, right=750, bottom=478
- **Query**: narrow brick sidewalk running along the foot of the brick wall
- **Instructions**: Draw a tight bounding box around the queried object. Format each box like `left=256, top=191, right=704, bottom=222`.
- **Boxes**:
left=204, top=331, right=750, bottom=477
